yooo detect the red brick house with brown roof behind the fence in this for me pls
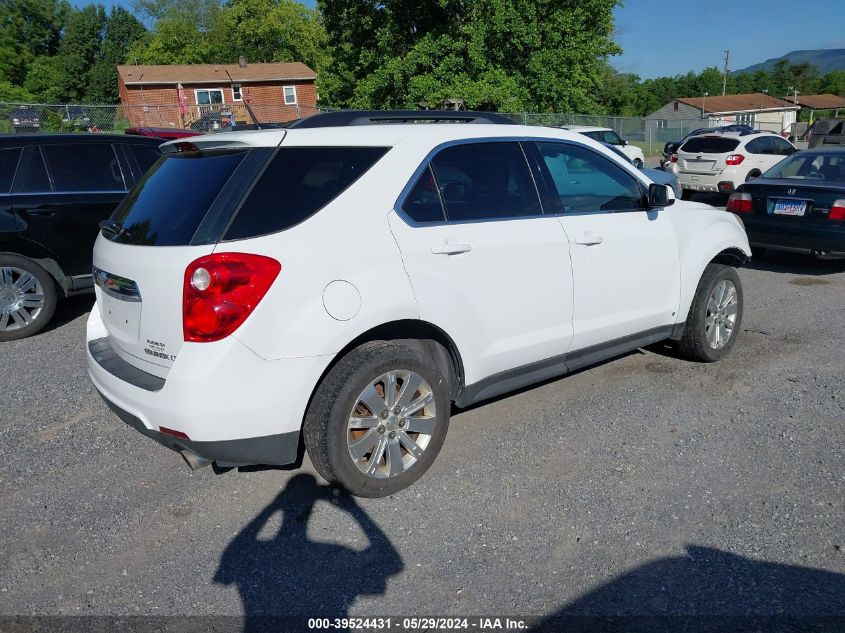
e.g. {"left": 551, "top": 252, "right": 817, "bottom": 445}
{"left": 117, "top": 59, "right": 318, "bottom": 127}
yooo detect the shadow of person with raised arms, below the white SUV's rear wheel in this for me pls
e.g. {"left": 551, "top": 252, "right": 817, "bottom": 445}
{"left": 214, "top": 474, "right": 404, "bottom": 633}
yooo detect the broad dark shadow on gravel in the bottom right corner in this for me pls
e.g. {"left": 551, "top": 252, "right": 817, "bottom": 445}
{"left": 530, "top": 545, "right": 845, "bottom": 633}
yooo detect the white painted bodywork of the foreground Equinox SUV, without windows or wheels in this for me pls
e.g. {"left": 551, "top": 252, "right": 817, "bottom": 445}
{"left": 87, "top": 124, "right": 750, "bottom": 456}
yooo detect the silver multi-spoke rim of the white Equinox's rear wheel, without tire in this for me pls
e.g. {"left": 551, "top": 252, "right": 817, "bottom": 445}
{"left": 346, "top": 369, "right": 437, "bottom": 479}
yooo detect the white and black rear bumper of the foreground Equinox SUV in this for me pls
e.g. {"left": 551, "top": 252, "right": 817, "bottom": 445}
{"left": 86, "top": 307, "right": 331, "bottom": 466}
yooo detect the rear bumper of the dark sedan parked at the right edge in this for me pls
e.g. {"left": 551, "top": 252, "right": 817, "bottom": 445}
{"left": 740, "top": 216, "right": 845, "bottom": 257}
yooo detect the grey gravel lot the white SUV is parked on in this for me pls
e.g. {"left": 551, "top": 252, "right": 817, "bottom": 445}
{"left": 0, "top": 249, "right": 845, "bottom": 630}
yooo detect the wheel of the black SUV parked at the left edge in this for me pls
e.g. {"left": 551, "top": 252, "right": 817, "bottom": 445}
{"left": 0, "top": 253, "right": 59, "bottom": 342}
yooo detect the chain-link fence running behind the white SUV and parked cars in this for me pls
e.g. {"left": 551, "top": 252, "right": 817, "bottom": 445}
{"left": 0, "top": 103, "right": 708, "bottom": 156}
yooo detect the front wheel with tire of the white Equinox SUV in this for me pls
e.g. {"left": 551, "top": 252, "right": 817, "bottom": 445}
{"left": 679, "top": 264, "right": 743, "bottom": 363}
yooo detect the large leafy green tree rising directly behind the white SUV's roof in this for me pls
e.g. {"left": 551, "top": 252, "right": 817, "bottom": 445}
{"left": 318, "top": 0, "right": 620, "bottom": 112}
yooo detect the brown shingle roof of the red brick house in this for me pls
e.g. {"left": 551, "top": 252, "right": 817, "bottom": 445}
{"left": 117, "top": 62, "right": 317, "bottom": 86}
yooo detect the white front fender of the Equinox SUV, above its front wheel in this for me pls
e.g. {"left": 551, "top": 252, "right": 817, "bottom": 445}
{"left": 669, "top": 200, "right": 751, "bottom": 322}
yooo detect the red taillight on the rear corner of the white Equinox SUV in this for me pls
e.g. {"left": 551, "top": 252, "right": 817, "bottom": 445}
{"left": 182, "top": 253, "right": 282, "bottom": 343}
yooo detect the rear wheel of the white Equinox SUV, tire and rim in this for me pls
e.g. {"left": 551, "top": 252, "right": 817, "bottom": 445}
{"left": 303, "top": 342, "right": 451, "bottom": 497}
